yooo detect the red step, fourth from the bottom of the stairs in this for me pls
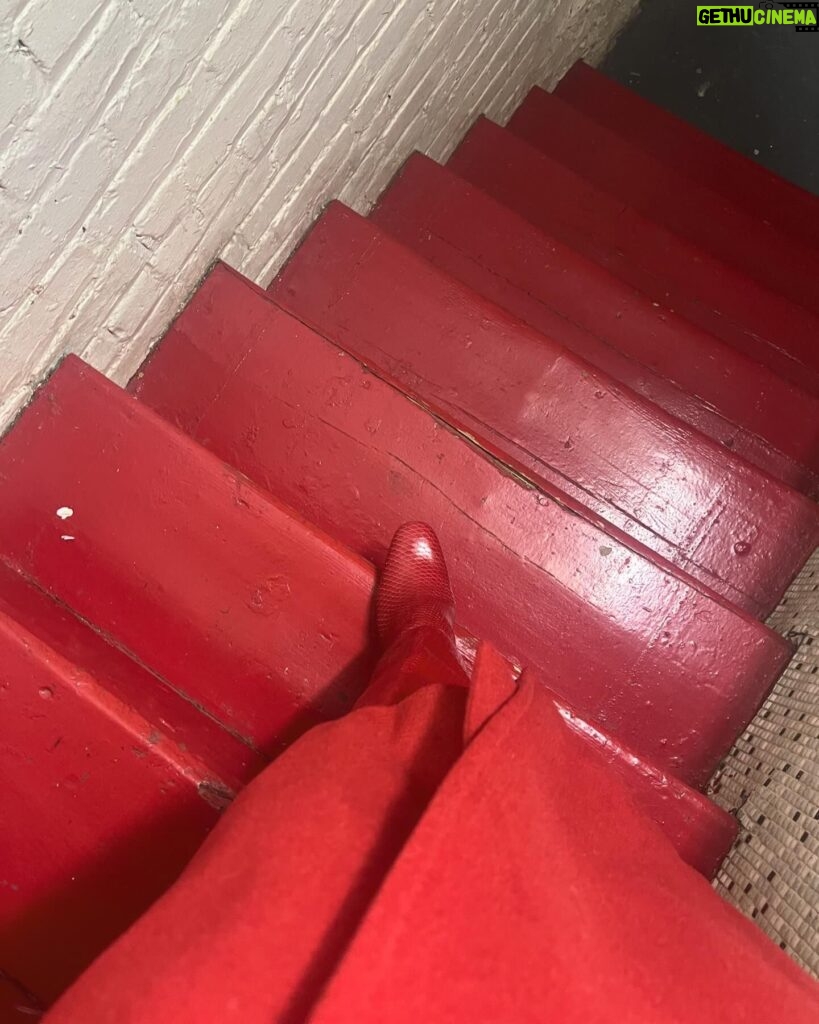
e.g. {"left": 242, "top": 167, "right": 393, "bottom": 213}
{"left": 370, "top": 154, "right": 819, "bottom": 497}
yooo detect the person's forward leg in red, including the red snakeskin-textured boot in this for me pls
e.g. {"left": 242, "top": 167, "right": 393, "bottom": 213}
{"left": 43, "top": 524, "right": 468, "bottom": 1024}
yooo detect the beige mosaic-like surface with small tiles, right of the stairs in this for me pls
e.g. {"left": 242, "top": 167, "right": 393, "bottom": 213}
{"left": 708, "top": 549, "right": 819, "bottom": 977}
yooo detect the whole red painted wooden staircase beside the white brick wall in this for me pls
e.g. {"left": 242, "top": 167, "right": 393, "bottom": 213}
{"left": 0, "top": 66, "right": 819, "bottom": 1020}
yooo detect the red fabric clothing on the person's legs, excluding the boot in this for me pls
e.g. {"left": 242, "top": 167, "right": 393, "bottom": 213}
{"left": 47, "top": 629, "right": 819, "bottom": 1024}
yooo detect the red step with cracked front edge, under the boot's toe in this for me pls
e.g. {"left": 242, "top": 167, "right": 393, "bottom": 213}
{"left": 135, "top": 264, "right": 788, "bottom": 783}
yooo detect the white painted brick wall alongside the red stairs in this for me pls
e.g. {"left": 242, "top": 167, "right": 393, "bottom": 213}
{"left": 0, "top": 0, "right": 636, "bottom": 428}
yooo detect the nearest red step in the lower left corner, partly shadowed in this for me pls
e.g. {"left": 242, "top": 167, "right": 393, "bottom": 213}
{"left": 0, "top": 561, "right": 257, "bottom": 1002}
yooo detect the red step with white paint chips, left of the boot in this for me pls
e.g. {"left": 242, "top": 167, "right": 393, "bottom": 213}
{"left": 0, "top": 358, "right": 375, "bottom": 754}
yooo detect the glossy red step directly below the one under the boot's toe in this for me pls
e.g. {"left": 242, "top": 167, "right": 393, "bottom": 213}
{"left": 270, "top": 204, "right": 819, "bottom": 615}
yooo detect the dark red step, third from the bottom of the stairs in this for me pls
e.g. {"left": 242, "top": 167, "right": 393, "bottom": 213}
{"left": 447, "top": 118, "right": 819, "bottom": 394}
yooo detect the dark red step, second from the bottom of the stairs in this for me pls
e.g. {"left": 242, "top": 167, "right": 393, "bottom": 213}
{"left": 507, "top": 87, "right": 819, "bottom": 333}
